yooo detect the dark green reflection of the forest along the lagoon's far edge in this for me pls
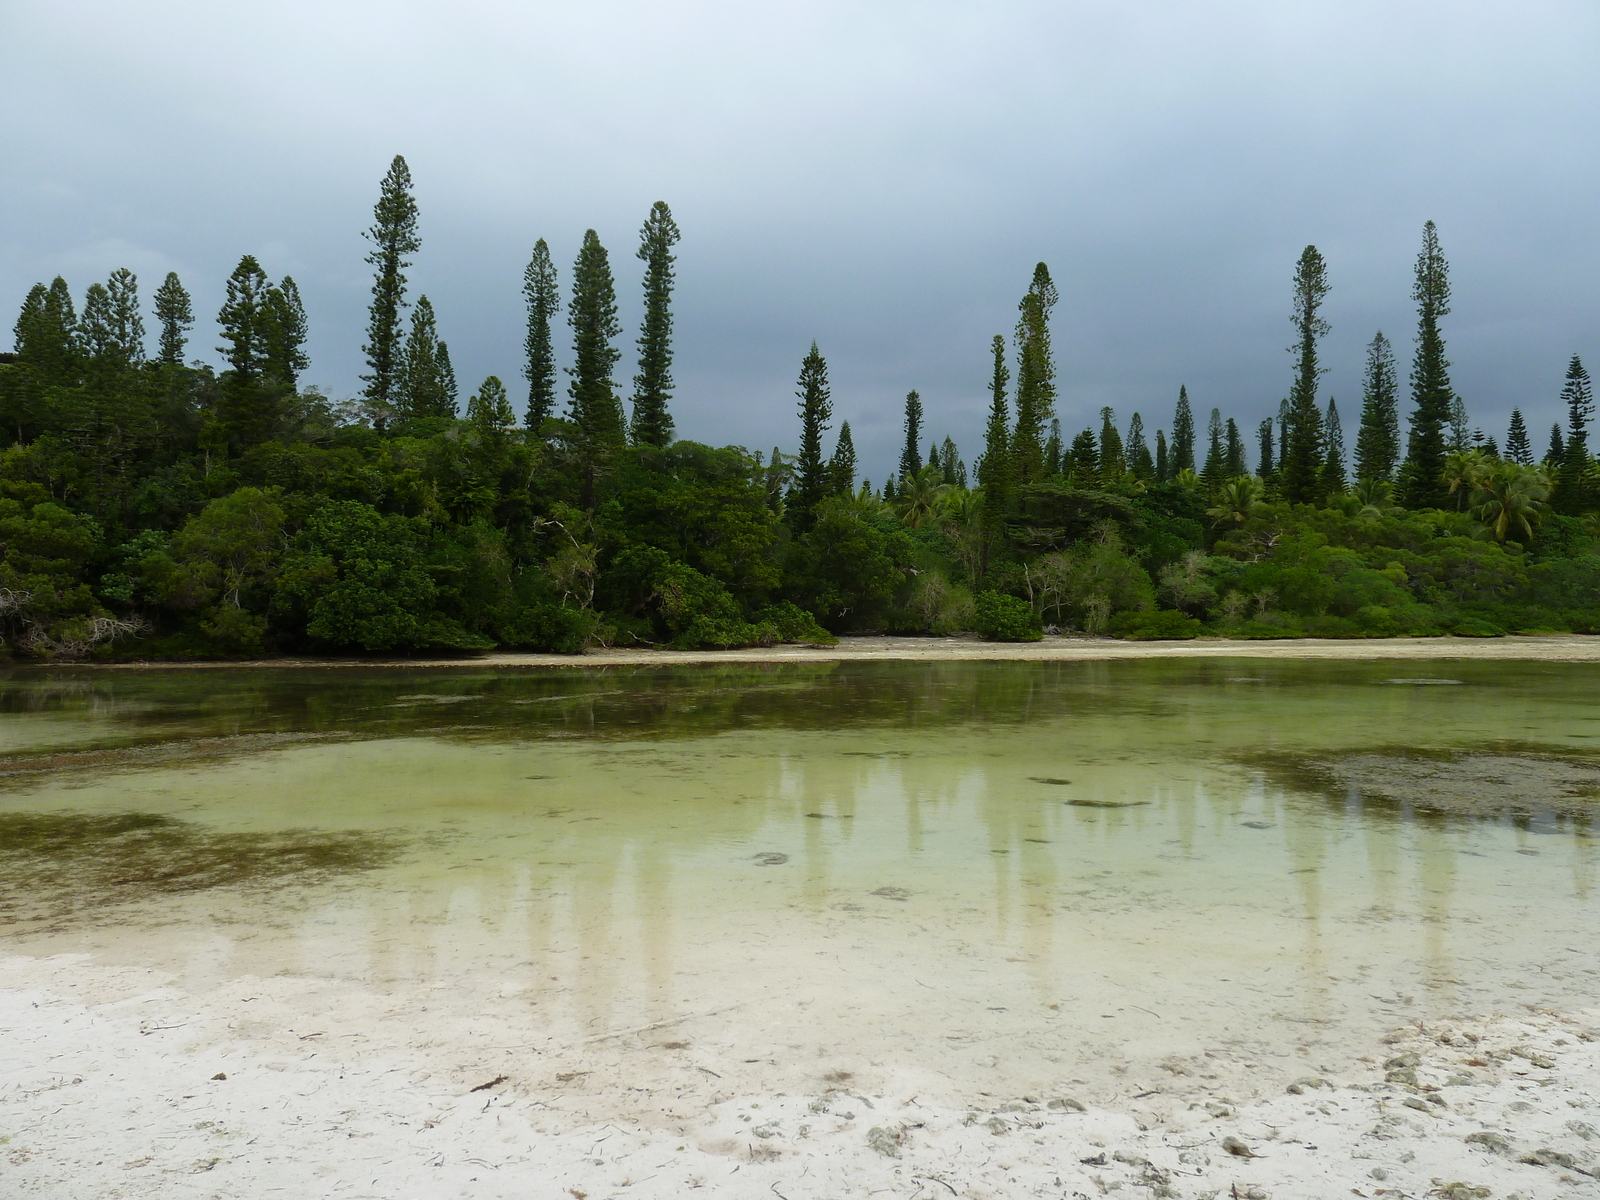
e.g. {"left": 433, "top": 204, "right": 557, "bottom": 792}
{"left": 9, "top": 659, "right": 1600, "bottom": 750}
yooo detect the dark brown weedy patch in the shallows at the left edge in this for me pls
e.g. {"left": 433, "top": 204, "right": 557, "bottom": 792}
{"left": 0, "top": 813, "right": 408, "bottom": 928}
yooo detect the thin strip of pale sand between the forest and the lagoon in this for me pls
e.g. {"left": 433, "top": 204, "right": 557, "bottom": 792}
{"left": 59, "top": 634, "right": 1600, "bottom": 670}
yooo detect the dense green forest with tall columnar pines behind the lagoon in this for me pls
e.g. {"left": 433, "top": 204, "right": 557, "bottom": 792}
{"left": 0, "top": 158, "right": 1600, "bottom": 659}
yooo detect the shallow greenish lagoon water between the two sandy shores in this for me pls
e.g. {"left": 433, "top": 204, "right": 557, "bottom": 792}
{"left": 0, "top": 659, "right": 1600, "bottom": 1104}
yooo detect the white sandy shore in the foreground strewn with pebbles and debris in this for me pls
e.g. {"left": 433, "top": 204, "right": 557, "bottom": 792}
{"left": 0, "top": 955, "right": 1600, "bottom": 1200}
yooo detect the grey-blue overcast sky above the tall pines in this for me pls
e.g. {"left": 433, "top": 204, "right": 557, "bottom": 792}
{"left": 0, "top": 0, "right": 1600, "bottom": 482}
